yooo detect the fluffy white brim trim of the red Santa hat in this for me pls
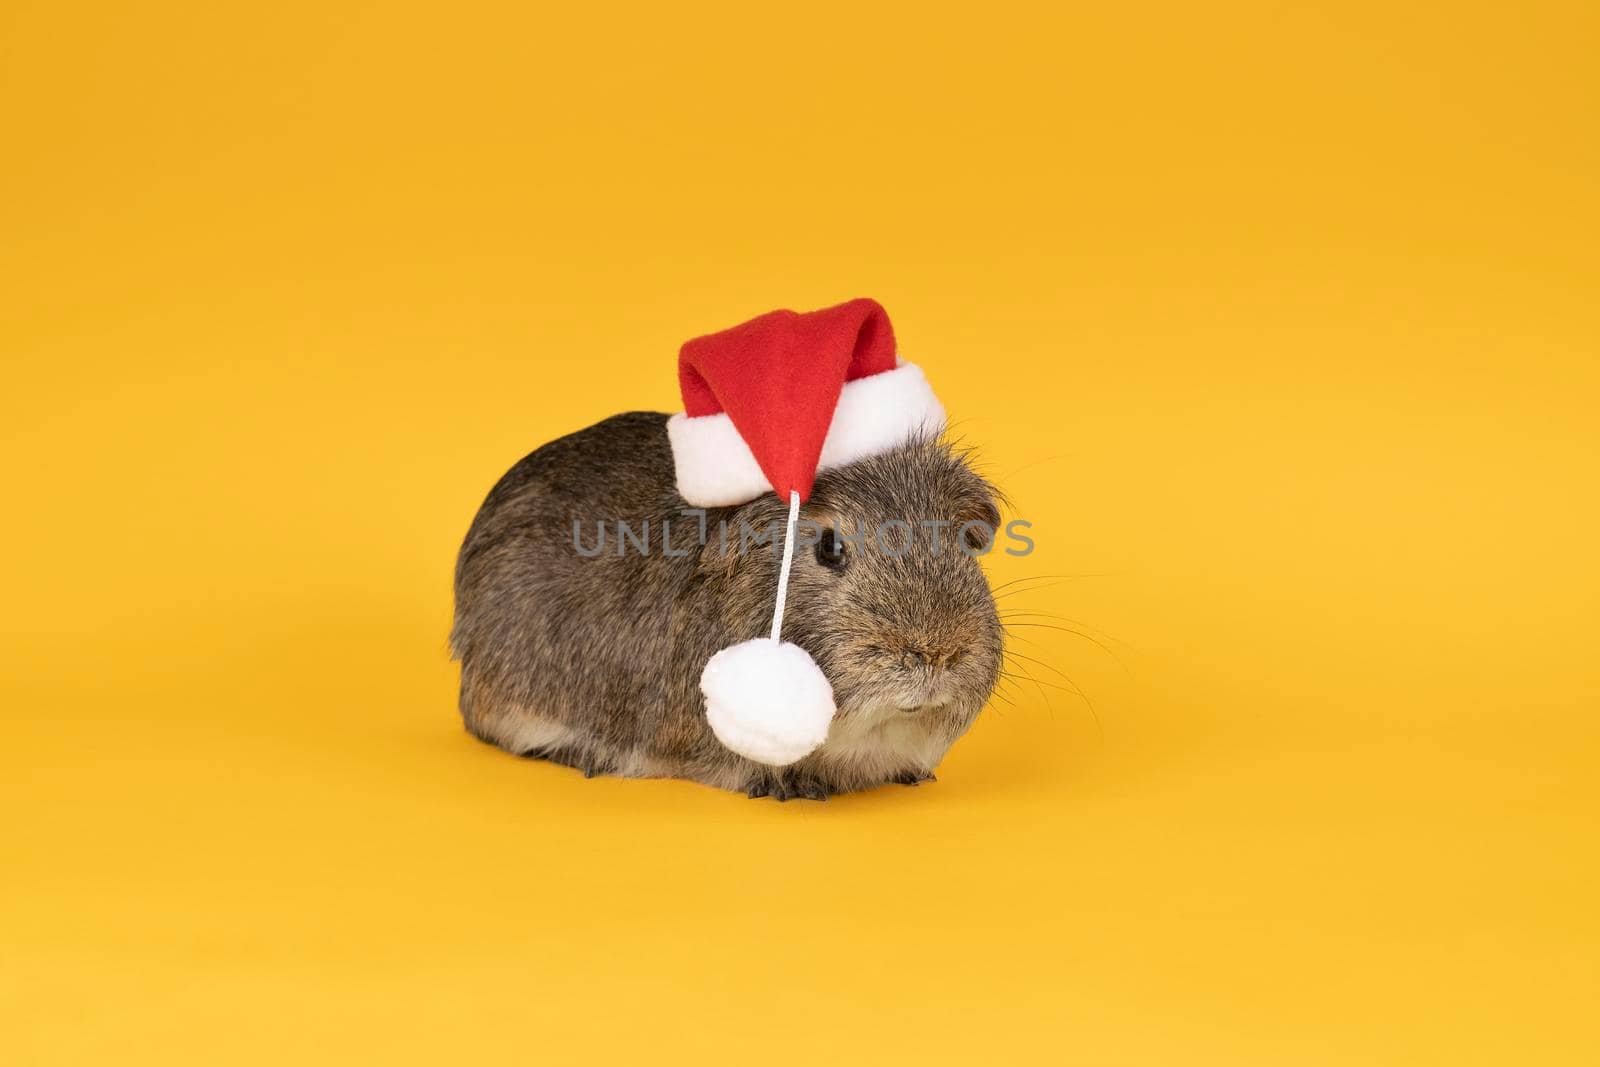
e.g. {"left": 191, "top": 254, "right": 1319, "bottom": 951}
{"left": 667, "top": 363, "right": 944, "bottom": 507}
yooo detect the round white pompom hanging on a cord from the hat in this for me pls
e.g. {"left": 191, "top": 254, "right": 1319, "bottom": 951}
{"left": 701, "top": 637, "right": 834, "bottom": 766}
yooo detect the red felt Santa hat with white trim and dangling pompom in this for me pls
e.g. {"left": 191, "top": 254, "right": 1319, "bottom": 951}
{"left": 667, "top": 299, "right": 944, "bottom": 766}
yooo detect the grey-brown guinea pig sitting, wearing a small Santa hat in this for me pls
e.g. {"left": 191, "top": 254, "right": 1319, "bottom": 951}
{"left": 451, "top": 411, "right": 1003, "bottom": 800}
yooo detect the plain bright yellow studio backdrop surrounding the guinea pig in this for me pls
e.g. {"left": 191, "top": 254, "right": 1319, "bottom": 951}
{"left": 0, "top": 0, "right": 1600, "bottom": 1064}
